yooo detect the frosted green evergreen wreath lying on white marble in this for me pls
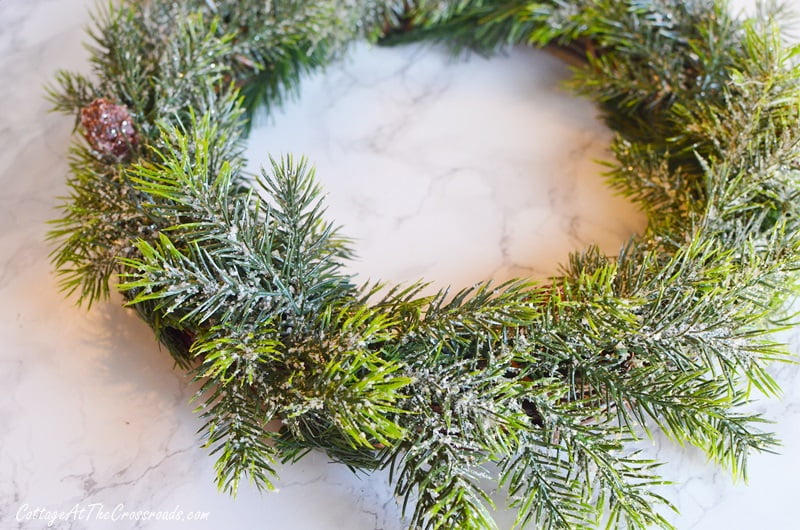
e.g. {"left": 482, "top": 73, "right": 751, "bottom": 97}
{"left": 51, "top": 0, "right": 800, "bottom": 529}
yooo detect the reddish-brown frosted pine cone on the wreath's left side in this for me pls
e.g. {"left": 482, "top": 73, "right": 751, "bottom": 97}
{"left": 81, "top": 98, "right": 139, "bottom": 162}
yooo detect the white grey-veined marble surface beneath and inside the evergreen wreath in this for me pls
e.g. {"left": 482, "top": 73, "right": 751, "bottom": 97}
{"left": 0, "top": 0, "right": 800, "bottom": 530}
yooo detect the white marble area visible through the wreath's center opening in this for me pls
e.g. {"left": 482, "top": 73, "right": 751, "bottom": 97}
{"left": 247, "top": 45, "right": 645, "bottom": 288}
